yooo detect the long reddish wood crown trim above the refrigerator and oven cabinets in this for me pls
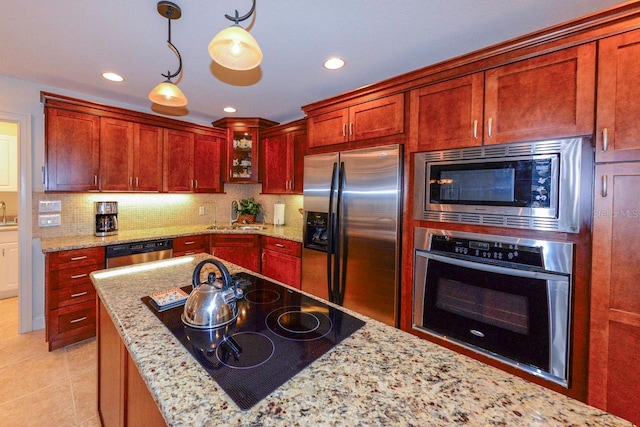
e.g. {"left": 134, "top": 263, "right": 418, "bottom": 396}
{"left": 302, "top": 1, "right": 640, "bottom": 116}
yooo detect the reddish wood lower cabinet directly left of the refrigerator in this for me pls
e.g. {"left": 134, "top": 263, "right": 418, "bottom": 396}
{"left": 261, "top": 236, "right": 302, "bottom": 289}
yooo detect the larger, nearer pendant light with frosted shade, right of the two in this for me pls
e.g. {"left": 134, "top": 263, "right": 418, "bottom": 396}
{"left": 209, "top": 0, "right": 262, "bottom": 71}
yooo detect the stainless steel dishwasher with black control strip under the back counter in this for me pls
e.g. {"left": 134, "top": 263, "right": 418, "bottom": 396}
{"left": 105, "top": 239, "right": 173, "bottom": 268}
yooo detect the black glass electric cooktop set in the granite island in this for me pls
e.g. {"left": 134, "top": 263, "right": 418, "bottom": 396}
{"left": 142, "top": 273, "right": 365, "bottom": 410}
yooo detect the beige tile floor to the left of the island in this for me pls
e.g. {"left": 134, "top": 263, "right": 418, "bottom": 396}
{"left": 0, "top": 297, "right": 100, "bottom": 427}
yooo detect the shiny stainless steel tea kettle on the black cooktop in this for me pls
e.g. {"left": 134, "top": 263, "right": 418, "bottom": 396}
{"left": 182, "top": 259, "right": 242, "bottom": 329}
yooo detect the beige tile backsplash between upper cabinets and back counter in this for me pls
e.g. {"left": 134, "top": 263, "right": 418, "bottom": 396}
{"left": 31, "top": 184, "right": 302, "bottom": 238}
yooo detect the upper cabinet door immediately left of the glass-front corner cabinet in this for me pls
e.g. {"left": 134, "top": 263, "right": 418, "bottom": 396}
{"left": 193, "top": 135, "right": 225, "bottom": 193}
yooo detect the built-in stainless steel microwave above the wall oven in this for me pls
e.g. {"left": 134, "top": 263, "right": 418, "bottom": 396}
{"left": 414, "top": 138, "right": 592, "bottom": 233}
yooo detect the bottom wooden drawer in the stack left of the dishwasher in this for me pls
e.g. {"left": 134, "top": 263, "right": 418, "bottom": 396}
{"left": 49, "top": 298, "right": 96, "bottom": 341}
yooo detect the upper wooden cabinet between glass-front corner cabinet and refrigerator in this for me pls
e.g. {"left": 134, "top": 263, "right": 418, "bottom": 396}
{"left": 260, "top": 120, "right": 307, "bottom": 194}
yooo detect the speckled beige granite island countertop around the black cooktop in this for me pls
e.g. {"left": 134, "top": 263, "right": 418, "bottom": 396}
{"left": 92, "top": 254, "right": 631, "bottom": 426}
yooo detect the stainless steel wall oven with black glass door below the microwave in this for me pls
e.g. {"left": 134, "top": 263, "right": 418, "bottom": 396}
{"left": 413, "top": 228, "right": 573, "bottom": 387}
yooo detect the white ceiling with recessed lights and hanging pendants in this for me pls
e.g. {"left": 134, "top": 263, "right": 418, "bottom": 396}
{"left": 0, "top": 0, "right": 623, "bottom": 123}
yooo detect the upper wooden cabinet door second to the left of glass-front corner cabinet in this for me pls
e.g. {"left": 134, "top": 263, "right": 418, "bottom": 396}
{"left": 162, "top": 129, "right": 194, "bottom": 192}
